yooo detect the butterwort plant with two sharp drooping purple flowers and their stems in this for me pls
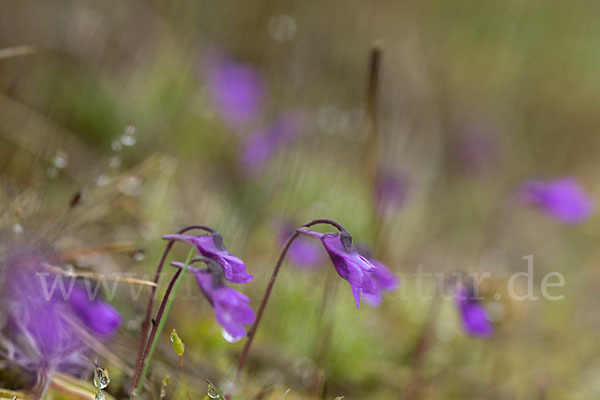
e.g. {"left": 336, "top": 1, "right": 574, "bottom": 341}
{"left": 130, "top": 225, "right": 254, "bottom": 398}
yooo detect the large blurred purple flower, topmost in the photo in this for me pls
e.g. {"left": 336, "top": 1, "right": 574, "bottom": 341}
{"left": 208, "top": 54, "right": 265, "bottom": 128}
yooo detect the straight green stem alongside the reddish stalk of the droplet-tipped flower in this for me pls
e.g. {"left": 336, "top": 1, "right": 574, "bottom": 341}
{"left": 132, "top": 249, "right": 195, "bottom": 397}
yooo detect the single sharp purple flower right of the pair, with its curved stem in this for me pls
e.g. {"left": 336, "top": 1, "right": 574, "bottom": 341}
{"left": 237, "top": 219, "right": 386, "bottom": 377}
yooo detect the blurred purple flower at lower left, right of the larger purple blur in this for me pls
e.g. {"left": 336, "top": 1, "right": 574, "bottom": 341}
{"left": 69, "top": 285, "right": 121, "bottom": 337}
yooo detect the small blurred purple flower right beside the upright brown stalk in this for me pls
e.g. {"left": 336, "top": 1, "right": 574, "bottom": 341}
{"left": 375, "top": 171, "right": 408, "bottom": 215}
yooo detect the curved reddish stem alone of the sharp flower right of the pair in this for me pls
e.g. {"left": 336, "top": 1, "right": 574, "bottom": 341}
{"left": 237, "top": 219, "right": 347, "bottom": 379}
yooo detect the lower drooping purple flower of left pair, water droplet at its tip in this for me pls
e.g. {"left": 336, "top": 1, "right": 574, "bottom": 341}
{"left": 171, "top": 262, "right": 255, "bottom": 342}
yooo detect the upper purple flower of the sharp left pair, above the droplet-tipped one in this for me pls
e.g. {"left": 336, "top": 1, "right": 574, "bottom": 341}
{"left": 163, "top": 232, "right": 253, "bottom": 283}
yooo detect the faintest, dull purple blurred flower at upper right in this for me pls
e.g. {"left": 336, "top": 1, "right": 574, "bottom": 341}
{"left": 451, "top": 122, "right": 499, "bottom": 175}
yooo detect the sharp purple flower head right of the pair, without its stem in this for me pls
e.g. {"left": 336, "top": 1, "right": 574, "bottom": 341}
{"left": 301, "top": 230, "right": 377, "bottom": 308}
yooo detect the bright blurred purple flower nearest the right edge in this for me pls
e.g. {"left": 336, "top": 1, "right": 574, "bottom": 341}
{"left": 521, "top": 178, "right": 594, "bottom": 224}
